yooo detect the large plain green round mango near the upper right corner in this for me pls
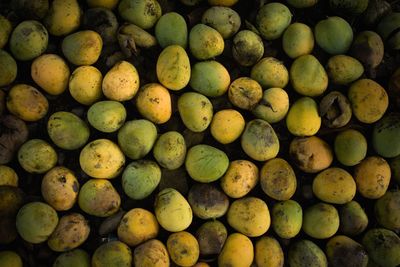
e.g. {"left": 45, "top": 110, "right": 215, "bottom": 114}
{"left": 314, "top": 16, "right": 353, "bottom": 55}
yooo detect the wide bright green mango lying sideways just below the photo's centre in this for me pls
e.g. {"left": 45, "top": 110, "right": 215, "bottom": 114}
{"left": 185, "top": 144, "right": 229, "bottom": 183}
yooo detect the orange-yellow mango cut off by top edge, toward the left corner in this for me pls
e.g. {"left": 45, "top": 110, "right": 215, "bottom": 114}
{"left": 44, "top": 0, "right": 82, "bottom": 36}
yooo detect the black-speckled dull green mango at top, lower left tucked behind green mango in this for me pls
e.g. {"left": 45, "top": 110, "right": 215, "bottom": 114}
{"left": 201, "top": 6, "right": 241, "bottom": 39}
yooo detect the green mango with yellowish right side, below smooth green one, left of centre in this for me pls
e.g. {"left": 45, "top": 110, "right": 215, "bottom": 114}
{"left": 121, "top": 160, "right": 161, "bottom": 200}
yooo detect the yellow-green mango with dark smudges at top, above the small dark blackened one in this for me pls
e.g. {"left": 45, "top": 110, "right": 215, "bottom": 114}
{"left": 256, "top": 2, "right": 292, "bottom": 41}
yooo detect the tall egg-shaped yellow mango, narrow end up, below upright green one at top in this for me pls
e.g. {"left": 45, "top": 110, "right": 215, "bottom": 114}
{"left": 156, "top": 45, "right": 190, "bottom": 91}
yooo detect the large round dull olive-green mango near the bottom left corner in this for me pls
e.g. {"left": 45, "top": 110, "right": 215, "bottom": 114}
{"left": 16, "top": 202, "right": 58, "bottom": 244}
